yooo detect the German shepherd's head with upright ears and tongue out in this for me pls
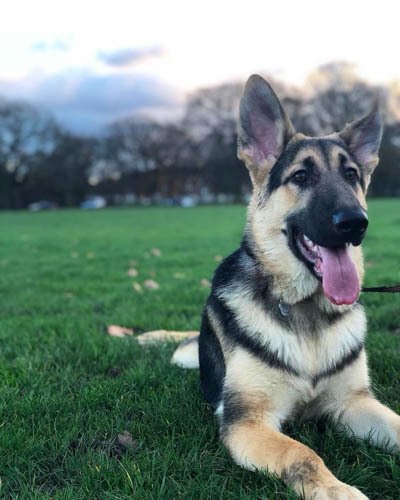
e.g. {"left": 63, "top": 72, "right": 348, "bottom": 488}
{"left": 238, "top": 75, "right": 382, "bottom": 305}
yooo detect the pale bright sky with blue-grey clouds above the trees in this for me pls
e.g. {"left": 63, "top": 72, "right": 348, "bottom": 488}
{"left": 0, "top": 0, "right": 400, "bottom": 134}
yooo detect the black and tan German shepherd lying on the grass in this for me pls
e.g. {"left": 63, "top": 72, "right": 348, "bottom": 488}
{"left": 170, "top": 75, "right": 400, "bottom": 500}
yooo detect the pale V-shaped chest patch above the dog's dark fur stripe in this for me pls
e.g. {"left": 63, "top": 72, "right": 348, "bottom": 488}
{"left": 236, "top": 292, "right": 366, "bottom": 379}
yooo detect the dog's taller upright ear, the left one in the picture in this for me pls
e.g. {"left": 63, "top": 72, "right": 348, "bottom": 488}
{"left": 238, "top": 75, "right": 295, "bottom": 188}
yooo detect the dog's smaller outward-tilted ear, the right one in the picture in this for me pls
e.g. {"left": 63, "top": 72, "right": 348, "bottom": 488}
{"left": 339, "top": 105, "right": 383, "bottom": 175}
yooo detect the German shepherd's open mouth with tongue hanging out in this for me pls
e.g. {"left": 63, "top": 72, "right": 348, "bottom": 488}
{"left": 295, "top": 233, "right": 360, "bottom": 305}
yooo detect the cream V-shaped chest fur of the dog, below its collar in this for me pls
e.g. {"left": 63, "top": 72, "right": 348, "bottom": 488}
{"left": 220, "top": 288, "right": 366, "bottom": 385}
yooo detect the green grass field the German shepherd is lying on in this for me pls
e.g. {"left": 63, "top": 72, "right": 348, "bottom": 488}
{"left": 0, "top": 200, "right": 400, "bottom": 500}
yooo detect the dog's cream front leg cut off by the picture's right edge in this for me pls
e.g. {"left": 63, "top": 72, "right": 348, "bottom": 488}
{"left": 339, "top": 389, "right": 400, "bottom": 453}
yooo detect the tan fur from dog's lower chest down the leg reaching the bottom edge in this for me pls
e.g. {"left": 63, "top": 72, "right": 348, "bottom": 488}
{"left": 223, "top": 349, "right": 366, "bottom": 499}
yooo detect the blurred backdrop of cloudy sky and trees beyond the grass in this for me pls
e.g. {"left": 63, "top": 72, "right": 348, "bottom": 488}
{"left": 0, "top": 0, "right": 400, "bottom": 210}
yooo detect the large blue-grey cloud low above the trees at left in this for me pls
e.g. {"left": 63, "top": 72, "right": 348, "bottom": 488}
{"left": 0, "top": 70, "right": 181, "bottom": 134}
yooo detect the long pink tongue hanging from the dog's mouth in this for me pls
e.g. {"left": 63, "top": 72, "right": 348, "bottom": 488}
{"left": 319, "top": 246, "right": 360, "bottom": 305}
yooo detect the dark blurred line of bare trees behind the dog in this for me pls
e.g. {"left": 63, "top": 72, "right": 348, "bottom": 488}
{"left": 0, "top": 64, "right": 400, "bottom": 209}
